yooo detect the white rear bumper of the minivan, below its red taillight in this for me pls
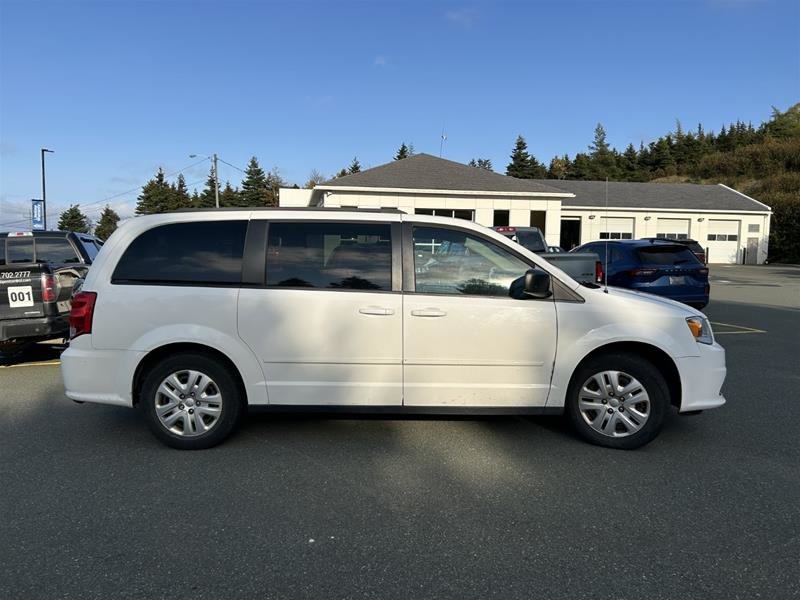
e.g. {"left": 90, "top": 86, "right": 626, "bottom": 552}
{"left": 61, "top": 335, "right": 145, "bottom": 406}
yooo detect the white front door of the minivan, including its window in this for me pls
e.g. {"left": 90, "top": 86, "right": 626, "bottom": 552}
{"left": 403, "top": 225, "right": 556, "bottom": 407}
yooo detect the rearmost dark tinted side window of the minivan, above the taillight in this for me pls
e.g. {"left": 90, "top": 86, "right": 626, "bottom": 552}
{"left": 112, "top": 221, "right": 247, "bottom": 284}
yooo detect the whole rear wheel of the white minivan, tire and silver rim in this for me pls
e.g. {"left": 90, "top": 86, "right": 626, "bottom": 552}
{"left": 139, "top": 354, "right": 244, "bottom": 450}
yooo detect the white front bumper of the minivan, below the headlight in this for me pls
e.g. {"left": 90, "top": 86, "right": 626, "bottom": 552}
{"left": 675, "top": 342, "right": 727, "bottom": 412}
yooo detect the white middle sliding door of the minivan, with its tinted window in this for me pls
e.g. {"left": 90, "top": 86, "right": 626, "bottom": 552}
{"left": 236, "top": 220, "right": 403, "bottom": 406}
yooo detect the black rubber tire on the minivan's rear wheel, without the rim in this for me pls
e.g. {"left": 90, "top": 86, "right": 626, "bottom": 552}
{"left": 139, "top": 353, "right": 245, "bottom": 450}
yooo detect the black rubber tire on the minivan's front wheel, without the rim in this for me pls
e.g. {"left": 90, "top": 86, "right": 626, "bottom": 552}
{"left": 565, "top": 353, "right": 670, "bottom": 450}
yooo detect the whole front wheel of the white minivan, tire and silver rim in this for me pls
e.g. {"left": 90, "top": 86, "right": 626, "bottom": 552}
{"left": 566, "top": 353, "right": 669, "bottom": 450}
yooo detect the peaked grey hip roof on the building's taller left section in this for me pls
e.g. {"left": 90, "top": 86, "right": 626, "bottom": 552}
{"left": 316, "top": 154, "right": 569, "bottom": 197}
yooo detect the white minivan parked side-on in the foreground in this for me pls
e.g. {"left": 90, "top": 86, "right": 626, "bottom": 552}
{"left": 61, "top": 209, "right": 725, "bottom": 449}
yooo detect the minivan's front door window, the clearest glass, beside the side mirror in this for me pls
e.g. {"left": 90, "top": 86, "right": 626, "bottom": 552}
{"left": 414, "top": 227, "right": 531, "bottom": 297}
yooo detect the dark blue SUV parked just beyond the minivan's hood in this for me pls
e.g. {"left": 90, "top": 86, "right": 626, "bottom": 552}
{"left": 577, "top": 238, "right": 711, "bottom": 309}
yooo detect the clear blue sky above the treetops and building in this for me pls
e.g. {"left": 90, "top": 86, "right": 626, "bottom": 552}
{"left": 0, "top": 0, "right": 800, "bottom": 229}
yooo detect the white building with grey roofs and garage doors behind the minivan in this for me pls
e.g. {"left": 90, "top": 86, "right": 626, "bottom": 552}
{"left": 280, "top": 154, "right": 772, "bottom": 264}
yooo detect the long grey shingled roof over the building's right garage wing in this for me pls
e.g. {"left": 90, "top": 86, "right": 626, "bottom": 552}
{"left": 534, "top": 179, "right": 770, "bottom": 212}
